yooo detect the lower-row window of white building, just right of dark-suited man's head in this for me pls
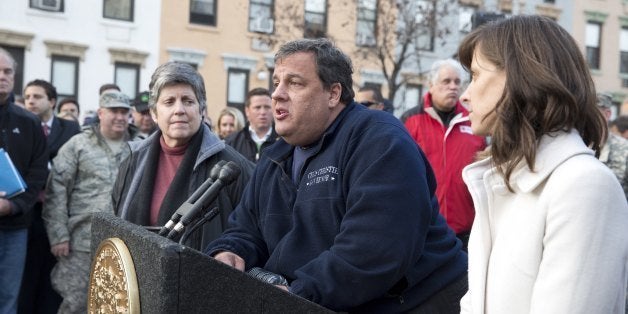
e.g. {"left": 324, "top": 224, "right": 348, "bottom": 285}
{"left": 50, "top": 55, "right": 79, "bottom": 99}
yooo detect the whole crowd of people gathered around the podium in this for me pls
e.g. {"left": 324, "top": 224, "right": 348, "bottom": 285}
{"left": 0, "top": 16, "right": 628, "bottom": 313}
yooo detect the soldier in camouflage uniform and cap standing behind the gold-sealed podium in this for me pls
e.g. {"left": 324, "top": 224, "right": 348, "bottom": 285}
{"left": 42, "top": 92, "right": 139, "bottom": 313}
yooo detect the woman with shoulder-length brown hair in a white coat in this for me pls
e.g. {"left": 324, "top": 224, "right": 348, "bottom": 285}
{"left": 458, "top": 16, "right": 628, "bottom": 313}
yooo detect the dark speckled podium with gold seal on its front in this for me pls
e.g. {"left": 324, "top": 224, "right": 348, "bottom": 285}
{"left": 88, "top": 213, "right": 334, "bottom": 314}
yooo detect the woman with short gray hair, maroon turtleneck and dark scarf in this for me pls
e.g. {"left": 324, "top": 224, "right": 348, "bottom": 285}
{"left": 113, "top": 61, "right": 254, "bottom": 250}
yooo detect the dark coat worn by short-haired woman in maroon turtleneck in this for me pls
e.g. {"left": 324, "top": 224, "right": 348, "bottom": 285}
{"left": 112, "top": 125, "right": 255, "bottom": 250}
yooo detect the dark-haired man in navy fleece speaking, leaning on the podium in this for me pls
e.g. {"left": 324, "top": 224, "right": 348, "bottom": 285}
{"left": 206, "top": 39, "right": 467, "bottom": 313}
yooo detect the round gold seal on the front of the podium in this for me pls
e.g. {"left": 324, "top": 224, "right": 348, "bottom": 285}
{"left": 87, "top": 238, "right": 140, "bottom": 314}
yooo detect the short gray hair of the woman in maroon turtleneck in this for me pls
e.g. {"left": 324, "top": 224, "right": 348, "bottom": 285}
{"left": 148, "top": 61, "right": 207, "bottom": 112}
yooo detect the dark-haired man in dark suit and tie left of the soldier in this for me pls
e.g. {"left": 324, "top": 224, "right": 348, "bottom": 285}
{"left": 18, "top": 80, "right": 81, "bottom": 313}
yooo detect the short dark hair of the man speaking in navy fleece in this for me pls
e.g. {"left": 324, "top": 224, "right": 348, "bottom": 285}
{"left": 275, "top": 38, "right": 355, "bottom": 104}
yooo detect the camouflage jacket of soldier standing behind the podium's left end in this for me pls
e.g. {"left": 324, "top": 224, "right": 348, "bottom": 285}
{"left": 42, "top": 125, "right": 137, "bottom": 252}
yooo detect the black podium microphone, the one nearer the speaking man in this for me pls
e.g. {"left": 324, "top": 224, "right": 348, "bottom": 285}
{"left": 168, "top": 161, "right": 240, "bottom": 239}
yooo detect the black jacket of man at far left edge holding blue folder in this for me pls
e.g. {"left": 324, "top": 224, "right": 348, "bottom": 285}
{"left": 0, "top": 102, "right": 48, "bottom": 229}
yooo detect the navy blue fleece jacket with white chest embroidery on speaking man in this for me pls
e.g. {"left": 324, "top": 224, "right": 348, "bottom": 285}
{"left": 206, "top": 103, "right": 467, "bottom": 312}
